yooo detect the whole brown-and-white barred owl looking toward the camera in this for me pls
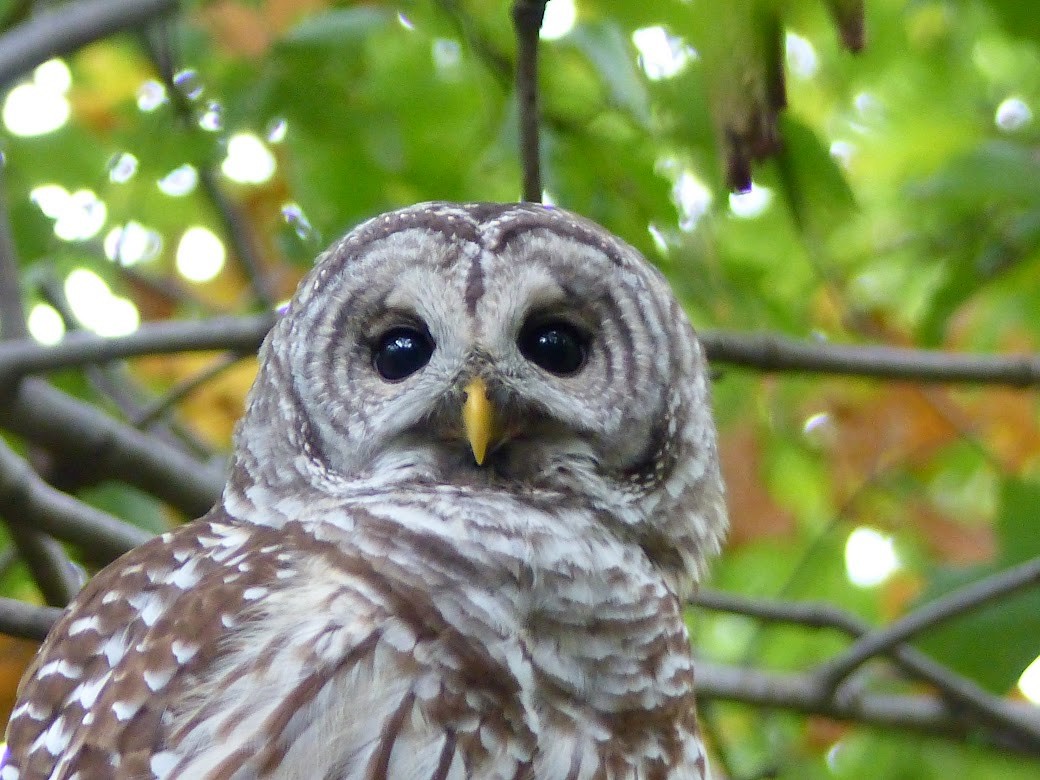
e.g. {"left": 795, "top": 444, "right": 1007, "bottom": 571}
{"left": 0, "top": 203, "right": 726, "bottom": 780}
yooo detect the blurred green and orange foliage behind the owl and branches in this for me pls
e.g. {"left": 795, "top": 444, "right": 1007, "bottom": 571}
{"left": 0, "top": 0, "right": 1040, "bottom": 780}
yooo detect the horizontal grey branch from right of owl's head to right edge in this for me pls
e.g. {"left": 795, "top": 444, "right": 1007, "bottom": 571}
{"left": 700, "top": 331, "right": 1040, "bottom": 387}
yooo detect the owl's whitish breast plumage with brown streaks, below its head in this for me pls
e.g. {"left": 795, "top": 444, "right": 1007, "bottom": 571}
{"left": 162, "top": 489, "right": 703, "bottom": 780}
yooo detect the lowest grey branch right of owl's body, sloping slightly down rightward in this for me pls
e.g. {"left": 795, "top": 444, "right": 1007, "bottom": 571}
{"left": 696, "top": 658, "right": 1040, "bottom": 756}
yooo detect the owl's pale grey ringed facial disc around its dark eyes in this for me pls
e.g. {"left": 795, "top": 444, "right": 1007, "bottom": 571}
{"left": 276, "top": 210, "right": 674, "bottom": 486}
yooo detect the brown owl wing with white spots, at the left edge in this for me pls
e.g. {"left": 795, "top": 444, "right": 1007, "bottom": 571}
{"left": 0, "top": 513, "right": 301, "bottom": 780}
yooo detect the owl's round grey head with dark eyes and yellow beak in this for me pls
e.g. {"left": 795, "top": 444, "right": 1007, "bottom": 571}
{"left": 225, "top": 203, "right": 726, "bottom": 590}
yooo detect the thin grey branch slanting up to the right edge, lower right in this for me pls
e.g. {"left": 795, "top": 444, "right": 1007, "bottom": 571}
{"left": 818, "top": 557, "right": 1040, "bottom": 694}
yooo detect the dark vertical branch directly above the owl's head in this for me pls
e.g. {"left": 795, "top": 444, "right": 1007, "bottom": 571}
{"left": 513, "top": 0, "right": 547, "bottom": 203}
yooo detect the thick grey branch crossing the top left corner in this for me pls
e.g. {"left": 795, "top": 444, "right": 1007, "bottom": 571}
{"left": 0, "top": 0, "right": 177, "bottom": 85}
